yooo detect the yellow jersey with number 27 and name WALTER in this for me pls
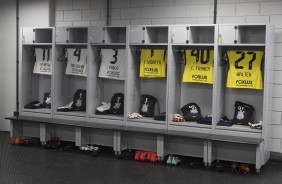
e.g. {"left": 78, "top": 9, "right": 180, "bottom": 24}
{"left": 223, "top": 50, "right": 264, "bottom": 89}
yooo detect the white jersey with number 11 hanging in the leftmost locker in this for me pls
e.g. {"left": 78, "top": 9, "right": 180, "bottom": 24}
{"left": 33, "top": 48, "right": 52, "bottom": 75}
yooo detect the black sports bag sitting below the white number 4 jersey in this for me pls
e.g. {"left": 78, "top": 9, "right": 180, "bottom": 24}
{"left": 72, "top": 89, "right": 86, "bottom": 111}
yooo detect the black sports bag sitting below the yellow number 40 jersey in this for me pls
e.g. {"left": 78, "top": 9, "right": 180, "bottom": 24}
{"left": 180, "top": 102, "right": 203, "bottom": 121}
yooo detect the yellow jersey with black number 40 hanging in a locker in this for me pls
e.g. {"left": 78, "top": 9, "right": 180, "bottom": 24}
{"left": 182, "top": 49, "right": 214, "bottom": 84}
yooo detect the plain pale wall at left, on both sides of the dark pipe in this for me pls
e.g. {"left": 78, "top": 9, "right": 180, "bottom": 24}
{"left": 0, "top": 0, "right": 50, "bottom": 131}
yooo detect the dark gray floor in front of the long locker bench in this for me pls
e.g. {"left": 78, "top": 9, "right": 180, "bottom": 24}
{"left": 0, "top": 132, "right": 282, "bottom": 184}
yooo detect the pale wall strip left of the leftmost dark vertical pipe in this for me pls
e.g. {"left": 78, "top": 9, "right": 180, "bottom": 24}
{"left": 0, "top": 0, "right": 16, "bottom": 130}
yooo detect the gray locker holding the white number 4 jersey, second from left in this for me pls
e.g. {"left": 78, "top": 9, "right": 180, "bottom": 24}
{"left": 53, "top": 27, "right": 89, "bottom": 121}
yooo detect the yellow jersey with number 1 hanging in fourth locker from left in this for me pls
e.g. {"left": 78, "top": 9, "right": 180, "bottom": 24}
{"left": 139, "top": 49, "right": 167, "bottom": 78}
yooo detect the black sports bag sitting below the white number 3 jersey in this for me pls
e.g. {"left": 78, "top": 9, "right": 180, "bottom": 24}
{"left": 110, "top": 93, "right": 124, "bottom": 114}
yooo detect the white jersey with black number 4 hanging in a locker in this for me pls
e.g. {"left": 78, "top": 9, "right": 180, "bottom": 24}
{"left": 66, "top": 48, "right": 87, "bottom": 76}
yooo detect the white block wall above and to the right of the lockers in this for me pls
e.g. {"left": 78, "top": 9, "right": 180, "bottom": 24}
{"left": 55, "top": 0, "right": 282, "bottom": 153}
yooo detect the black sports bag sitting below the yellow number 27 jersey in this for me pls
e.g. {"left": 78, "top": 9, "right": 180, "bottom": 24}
{"left": 232, "top": 101, "right": 255, "bottom": 125}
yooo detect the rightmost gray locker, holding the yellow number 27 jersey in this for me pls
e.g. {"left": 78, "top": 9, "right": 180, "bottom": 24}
{"left": 215, "top": 24, "right": 271, "bottom": 138}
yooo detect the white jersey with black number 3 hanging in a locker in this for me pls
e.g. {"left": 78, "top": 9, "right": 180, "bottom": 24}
{"left": 99, "top": 49, "right": 125, "bottom": 80}
